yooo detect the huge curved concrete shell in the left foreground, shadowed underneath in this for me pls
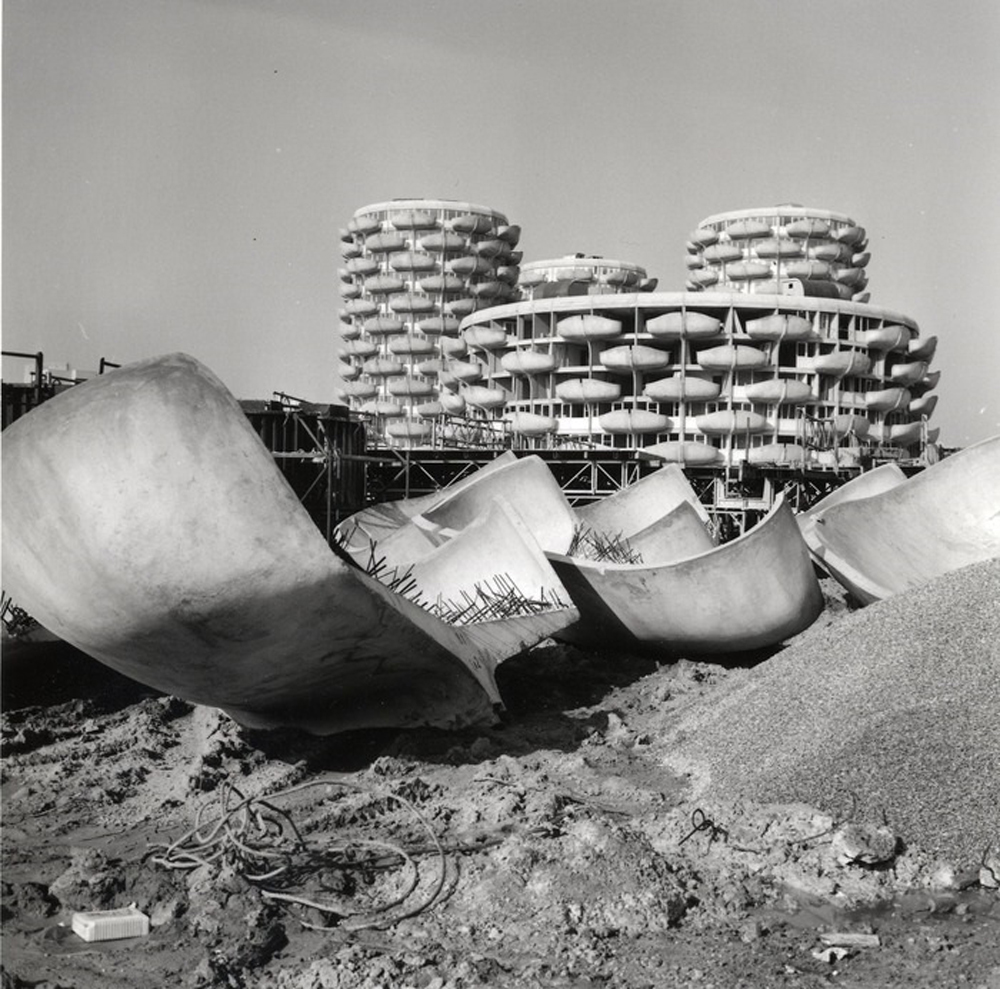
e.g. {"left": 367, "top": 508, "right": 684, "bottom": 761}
{"left": 3, "top": 354, "right": 564, "bottom": 733}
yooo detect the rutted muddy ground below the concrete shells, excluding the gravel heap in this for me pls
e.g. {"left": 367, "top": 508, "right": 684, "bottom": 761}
{"left": 2, "top": 592, "right": 1000, "bottom": 989}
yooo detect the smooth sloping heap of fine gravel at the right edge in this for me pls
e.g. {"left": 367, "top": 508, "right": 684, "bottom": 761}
{"left": 671, "top": 560, "right": 1000, "bottom": 868}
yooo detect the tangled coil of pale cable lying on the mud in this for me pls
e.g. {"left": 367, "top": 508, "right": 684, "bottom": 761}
{"left": 147, "top": 778, "right": 447, "bottom": 930}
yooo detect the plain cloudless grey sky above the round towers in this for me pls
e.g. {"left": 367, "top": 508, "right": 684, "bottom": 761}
{"left": 2, "top": 0, "right": 1000, "bottom": 446}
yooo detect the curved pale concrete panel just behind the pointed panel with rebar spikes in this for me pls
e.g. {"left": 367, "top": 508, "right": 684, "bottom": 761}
{"left": 421, "top": 455, "right": 576, "bottom": 553}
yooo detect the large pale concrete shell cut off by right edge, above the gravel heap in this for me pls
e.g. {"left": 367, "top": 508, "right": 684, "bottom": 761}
{"left": 810, "top": 436, "right": 1000, "bottom": 604}
